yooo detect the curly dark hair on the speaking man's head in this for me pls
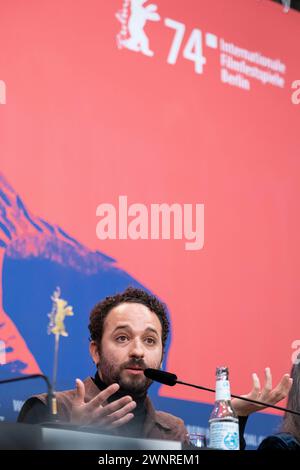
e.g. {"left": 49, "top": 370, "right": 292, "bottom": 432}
{"left": 89, "top": 287, "right": 170, "bottom": 351}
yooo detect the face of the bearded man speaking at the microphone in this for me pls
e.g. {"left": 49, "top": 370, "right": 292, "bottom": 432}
{"left": 91, "top": 302, "right": 163, "bottom": 396}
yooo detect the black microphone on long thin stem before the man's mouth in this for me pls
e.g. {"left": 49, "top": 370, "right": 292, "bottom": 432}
{"left": 144, "top": 368, "right": 300, "bottom": 416}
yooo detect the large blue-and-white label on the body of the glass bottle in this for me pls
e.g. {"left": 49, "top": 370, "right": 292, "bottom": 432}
{"left": 209, "top": 421, "right": 240, "bottom": 450}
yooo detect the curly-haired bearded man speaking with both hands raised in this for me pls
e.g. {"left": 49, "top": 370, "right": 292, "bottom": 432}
{"left": 18, "top": 287, "right": 291, "bottom": 443}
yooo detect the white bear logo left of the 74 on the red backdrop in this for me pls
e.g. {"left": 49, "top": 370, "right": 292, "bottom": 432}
{"left": 116, "top": 0, "right": 160, "bottom": 57}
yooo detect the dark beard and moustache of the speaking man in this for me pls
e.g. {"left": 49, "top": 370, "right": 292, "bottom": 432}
{"left": 98, "top": 353, "right": 152, "bottom": 398}
